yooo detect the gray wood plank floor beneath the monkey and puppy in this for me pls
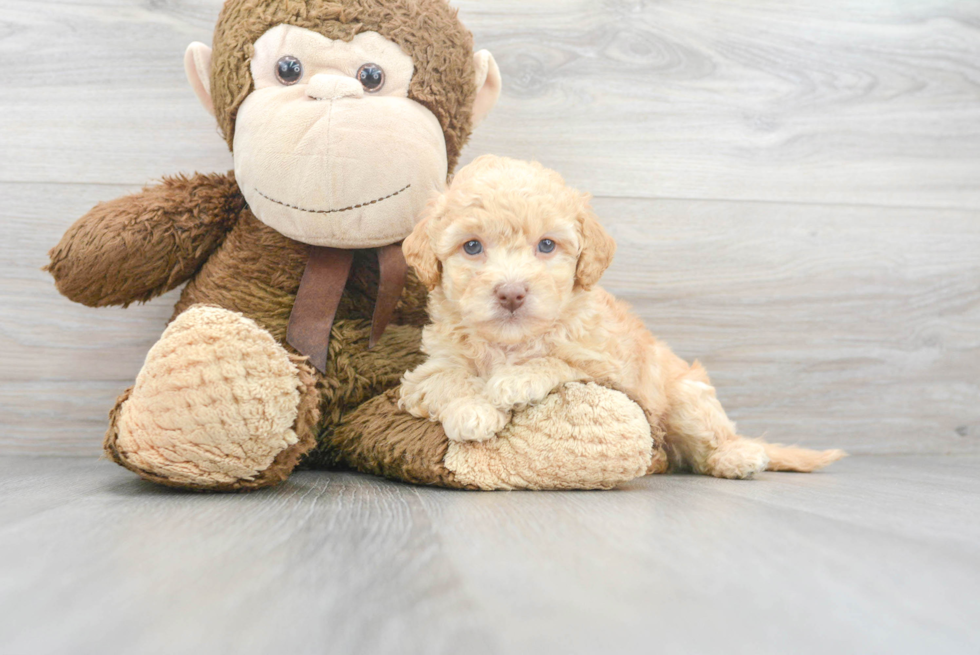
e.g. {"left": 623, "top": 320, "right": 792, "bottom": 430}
{"left": 0, "top": 456, "right": 980, "bottom": 655}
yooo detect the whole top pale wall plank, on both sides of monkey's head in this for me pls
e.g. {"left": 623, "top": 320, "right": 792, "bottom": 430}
{"left": 0, "top": 0, "right": 980, "bottom": 208}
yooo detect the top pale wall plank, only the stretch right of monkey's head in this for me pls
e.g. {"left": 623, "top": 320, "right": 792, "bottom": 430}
{"left": 461, "top": 0, "right": 980, "bottom": 209}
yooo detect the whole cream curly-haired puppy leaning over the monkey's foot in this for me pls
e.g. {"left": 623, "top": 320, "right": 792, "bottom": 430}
{"left": 400, "top": 156, "right": 844, "bottom": 478}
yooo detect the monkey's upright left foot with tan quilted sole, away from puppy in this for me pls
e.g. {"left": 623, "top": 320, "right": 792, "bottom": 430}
{"left": 105, "top": 305, "right": 317, "bottom": 491}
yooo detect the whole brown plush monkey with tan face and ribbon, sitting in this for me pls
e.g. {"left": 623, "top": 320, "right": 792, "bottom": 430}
{"left": 48, "top": 0, "right": 666, "bottom": 490}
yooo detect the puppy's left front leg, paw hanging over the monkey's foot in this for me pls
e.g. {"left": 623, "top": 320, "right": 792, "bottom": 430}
{"left": 398, "top": 359, "right": 510, "bottom": 441}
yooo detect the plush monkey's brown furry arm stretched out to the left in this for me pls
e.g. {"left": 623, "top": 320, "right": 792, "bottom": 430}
{"left": 45, "top": 172, "right": 245, "bottom": 307}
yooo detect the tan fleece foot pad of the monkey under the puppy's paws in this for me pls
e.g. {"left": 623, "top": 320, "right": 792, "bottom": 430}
{"left": 445, "top": 382, "right": 655, "bottom": 490}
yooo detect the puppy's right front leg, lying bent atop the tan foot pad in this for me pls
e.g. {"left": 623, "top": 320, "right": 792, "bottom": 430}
{"left": 485, "top": 357, "right": 585, "bottom": 411}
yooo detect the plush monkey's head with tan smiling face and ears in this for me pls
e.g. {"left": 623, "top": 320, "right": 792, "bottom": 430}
{"left": 184, "top": 0, "right": 500, "bottom": 248}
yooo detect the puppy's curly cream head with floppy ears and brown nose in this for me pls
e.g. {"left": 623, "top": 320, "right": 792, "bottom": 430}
{"left": 403, "top": 155, "right": 616, "bottom": 343}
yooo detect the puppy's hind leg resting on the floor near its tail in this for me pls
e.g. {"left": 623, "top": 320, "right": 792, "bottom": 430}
{"left": 667, "top": 362, "right": 769, "bottom": 478}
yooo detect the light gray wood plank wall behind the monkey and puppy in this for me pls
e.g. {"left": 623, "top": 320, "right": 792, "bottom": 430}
{"left": 0, "top": 0, "right": 980, "bottom": 456}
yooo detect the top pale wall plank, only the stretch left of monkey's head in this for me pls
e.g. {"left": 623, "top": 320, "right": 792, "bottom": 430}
{"left": 0, "top": 0, "right": 231, "bottom": 185}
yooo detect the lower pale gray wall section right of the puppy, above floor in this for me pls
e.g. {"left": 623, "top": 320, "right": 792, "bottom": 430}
{"left": 596, "top": 200, "right": 980, "bottom": 453}
